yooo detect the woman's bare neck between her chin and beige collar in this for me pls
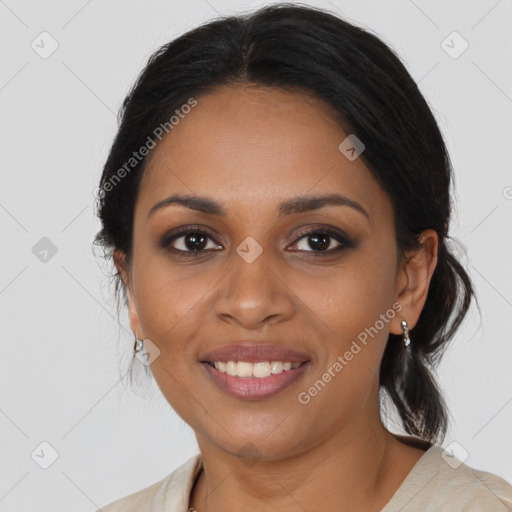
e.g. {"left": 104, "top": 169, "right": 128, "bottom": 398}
{"left": 190, "top": 400, "right": 424, "bottom": 512}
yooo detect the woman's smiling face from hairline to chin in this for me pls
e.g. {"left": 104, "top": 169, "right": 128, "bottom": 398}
{"left": 116, "top": 86, "right": 418, "bottom": 460}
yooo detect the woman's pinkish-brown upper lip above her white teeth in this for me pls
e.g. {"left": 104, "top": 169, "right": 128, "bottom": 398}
{"left": 200, "top": 341, "right": 309, "bottom": 363}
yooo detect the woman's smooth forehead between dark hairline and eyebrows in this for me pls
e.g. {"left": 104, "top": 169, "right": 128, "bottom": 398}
{"left": 138, "top": 85, "right": 389, "bottom": 222}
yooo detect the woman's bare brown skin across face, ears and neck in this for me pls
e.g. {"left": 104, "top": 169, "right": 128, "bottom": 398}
{"left": 114, "top": 84, "right": 438, "bottom": 512}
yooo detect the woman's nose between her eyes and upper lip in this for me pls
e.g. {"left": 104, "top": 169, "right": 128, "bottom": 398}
{"left": 213, "top": 243, "right": 296, "bottom": 329}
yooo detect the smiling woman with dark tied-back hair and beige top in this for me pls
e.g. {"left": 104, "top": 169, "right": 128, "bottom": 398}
{"left": 96, "top": 4, "right": 512, "bottom": 512}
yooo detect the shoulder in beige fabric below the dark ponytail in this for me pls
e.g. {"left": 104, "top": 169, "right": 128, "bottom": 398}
{"left": 382, "top": 446, "right": 512, "bottom": 512}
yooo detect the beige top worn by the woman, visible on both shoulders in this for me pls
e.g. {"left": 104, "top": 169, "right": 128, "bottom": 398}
{"left": 96, "top": 446, "right": 512, "bottom": 512}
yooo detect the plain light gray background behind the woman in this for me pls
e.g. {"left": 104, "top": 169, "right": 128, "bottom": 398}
{"left": 0, "top": 0, "right": 512, "bottom": 512}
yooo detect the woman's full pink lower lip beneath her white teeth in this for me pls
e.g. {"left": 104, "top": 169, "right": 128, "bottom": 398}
{"left": 201, "top": 361, "right": 310, "bottom": 400}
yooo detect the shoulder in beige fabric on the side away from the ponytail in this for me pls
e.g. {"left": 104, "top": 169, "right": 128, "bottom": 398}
{"left": 96, "top": 454, "right": 202, "bottom": 512}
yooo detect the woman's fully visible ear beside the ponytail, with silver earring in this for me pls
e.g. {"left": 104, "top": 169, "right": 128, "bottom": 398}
{"left": 390, "top": 229, "right": 439, "bottom": 334}
